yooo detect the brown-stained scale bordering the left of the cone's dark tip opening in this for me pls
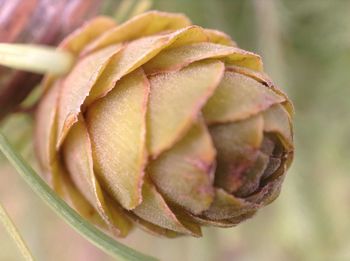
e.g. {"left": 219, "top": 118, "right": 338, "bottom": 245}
{"left": 209, "top": 116, "right": 264, "bottom": 193}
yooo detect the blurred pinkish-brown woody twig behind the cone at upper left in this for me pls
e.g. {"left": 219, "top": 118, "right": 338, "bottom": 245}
{"left": 0, "top": 0, "right": 103, "bottom": 120}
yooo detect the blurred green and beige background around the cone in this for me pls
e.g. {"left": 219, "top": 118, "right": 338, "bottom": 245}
{"left": 0, "top": 0, "right": 350, "bottom": 261}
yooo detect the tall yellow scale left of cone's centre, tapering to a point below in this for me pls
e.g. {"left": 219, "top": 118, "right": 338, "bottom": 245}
{"left": 86, "top": 70, "right": 149, "bottom": 209}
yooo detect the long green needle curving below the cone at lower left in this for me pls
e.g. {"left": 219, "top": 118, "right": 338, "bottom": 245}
{"left": 0, "top": 132, "right": 156, "bottom": 261}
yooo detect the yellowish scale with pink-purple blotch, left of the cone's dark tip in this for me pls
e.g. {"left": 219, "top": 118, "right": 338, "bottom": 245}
{"left": 147, "top": 121, "right": 216, "bottom": 214}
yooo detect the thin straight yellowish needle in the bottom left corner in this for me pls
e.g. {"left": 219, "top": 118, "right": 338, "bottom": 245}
{"left": 0, "top": 203, "right": 34, "bottom": 261}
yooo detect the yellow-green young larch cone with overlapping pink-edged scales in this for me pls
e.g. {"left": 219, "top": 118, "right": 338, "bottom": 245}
{"left": 36, "top": 11, "right": 293, "bottom": 237}
